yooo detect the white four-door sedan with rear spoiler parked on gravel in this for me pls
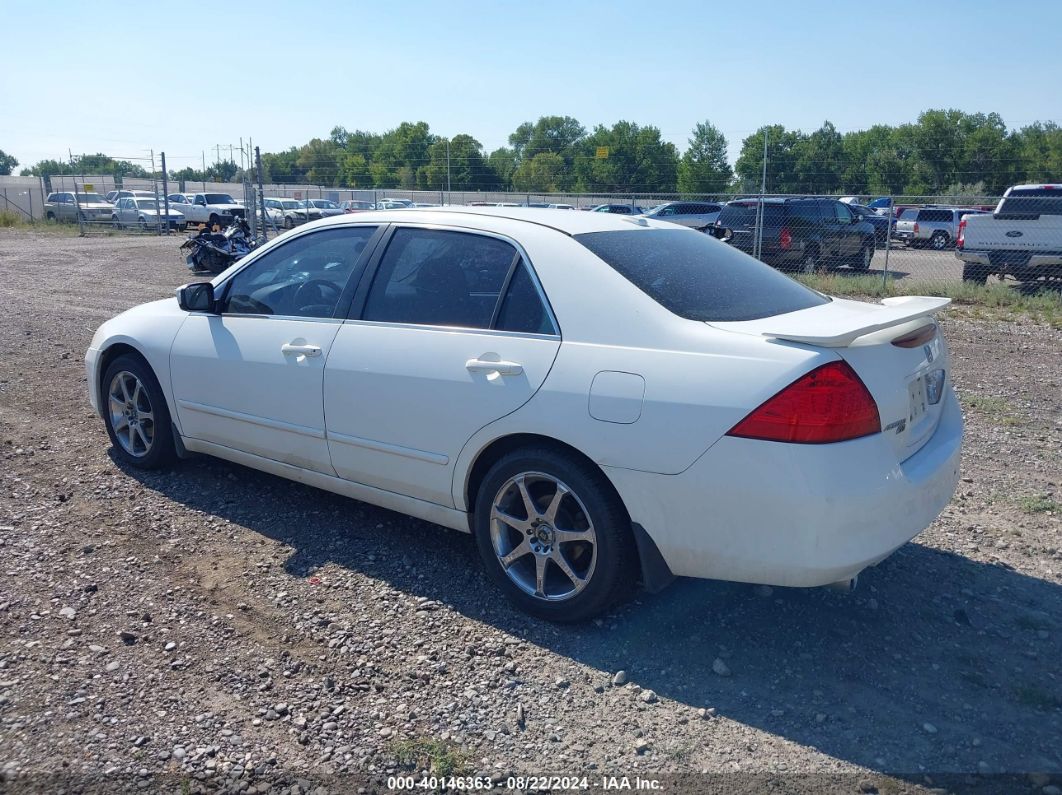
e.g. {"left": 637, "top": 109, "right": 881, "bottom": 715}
{"left": 85, "top": 207, "right": 962, "bottom": 621}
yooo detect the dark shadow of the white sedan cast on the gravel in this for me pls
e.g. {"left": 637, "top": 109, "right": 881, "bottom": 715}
{"left": 122, "top": 450, "right": 1062, "bottom": 776}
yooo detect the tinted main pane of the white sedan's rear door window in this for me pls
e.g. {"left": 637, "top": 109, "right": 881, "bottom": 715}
{"left": 362, "top": 228, "right": 518, "bottom": 328}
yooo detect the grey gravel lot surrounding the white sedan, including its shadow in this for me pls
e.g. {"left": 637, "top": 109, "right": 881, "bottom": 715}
{"left": 0, "top": 230, "right": 1062, "bottom": 795}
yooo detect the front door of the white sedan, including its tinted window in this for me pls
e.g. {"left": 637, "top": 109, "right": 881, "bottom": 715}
{"left": 170, "top": 225, "right": 386, "bottom": 474}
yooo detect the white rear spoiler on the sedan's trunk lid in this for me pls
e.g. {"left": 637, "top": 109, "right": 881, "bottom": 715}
{"left": 710, "top": 295, "right": 952, "bottom": 348}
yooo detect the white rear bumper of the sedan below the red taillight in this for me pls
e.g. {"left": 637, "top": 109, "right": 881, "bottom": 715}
{"left": 605, "top": 390, "right": 962, "bottom": 587}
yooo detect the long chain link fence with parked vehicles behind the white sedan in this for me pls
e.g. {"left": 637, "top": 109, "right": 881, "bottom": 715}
{"left": 16, "top": 154, "right": 1062, "bottom": 290}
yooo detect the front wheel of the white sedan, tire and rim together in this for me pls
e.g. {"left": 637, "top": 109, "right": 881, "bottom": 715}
{"left": 102, "top": 355, "right": 175, "bottom": 469}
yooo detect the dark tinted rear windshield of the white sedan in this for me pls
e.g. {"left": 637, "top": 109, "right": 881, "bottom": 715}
{"left": 575, "top": 229, "right": 829, "bottom": 322}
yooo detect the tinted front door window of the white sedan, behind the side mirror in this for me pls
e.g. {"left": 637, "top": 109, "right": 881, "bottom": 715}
{"left": 222, "top": 226, "right": 376, "bottom": 317}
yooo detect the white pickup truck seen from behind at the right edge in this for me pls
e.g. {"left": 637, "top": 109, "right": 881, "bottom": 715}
{"left": 955, "top": 185, "right": 1062, "bottom": 284}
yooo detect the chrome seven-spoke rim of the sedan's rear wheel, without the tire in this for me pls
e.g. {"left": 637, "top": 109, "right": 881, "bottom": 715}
{"left": 491, "top": 472, "right": 597, "bottom": 602}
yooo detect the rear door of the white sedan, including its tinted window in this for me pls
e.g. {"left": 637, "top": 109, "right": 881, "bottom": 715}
{"left": 325, "top": 225, "right": 560, "bottom": 505}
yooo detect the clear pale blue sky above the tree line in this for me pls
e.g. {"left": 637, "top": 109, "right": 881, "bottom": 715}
{"left": 0, "top": 0, "right": 1062, "bottom": 169}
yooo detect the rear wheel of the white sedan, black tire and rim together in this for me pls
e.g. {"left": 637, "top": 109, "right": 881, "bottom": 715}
{"left": 474, "top": 448, "right": 637, "bottom": 622}
